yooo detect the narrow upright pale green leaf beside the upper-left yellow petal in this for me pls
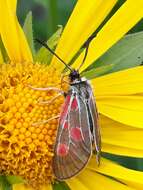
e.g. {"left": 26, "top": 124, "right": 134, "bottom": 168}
{"left": 23, "top": 11, "right": 35, "bottom": 55}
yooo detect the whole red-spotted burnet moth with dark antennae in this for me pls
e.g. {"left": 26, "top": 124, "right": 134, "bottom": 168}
{"left": 37, "top": 35, "right": 101, "bottom": 181}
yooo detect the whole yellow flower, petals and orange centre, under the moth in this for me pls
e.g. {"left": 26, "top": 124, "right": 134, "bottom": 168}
{"left": 0, "top": 0, "right": 143, "bottom": 190}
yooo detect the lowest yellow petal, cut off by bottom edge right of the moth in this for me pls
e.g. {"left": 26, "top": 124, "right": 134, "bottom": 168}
{"left": 77, "top": 169, "right": 135, "bottom": 190}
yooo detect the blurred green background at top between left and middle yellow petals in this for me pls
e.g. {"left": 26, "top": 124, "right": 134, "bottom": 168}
{"left": 17, "top": 0, "right": 76, "bottom": 40}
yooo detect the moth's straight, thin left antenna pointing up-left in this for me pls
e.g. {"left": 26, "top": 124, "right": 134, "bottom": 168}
{"left": 35, "top": 39, "right": 73, "bottom": 71}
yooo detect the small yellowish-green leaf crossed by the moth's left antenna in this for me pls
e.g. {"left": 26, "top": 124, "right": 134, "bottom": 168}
{"left": 35, "top": 26, "right": 63, "bottom": 64}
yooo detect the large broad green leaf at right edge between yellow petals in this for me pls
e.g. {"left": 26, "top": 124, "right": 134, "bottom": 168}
{"left": 91, "top": 32, "right": 143, "bottom": 73}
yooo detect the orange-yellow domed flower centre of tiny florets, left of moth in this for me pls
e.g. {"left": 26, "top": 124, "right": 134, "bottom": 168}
{"left": 0, "top": 63, "right": 68, "bottom": 189}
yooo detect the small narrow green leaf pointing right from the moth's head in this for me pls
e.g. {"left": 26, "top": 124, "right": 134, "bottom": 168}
{"left": 81, "top": 64, "right": 114, "bottom": 79}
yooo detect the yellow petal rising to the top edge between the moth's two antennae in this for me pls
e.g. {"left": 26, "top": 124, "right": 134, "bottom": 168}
{"left": 52, "top": 0, "right": 117, "bottom": 70}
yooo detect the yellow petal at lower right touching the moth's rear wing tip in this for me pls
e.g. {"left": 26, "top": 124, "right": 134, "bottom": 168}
{"left": 88, "top": 158, "right": 143, "bottom": 190}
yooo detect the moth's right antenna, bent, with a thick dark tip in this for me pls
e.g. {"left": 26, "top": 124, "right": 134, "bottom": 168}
{"left": 78, "top": 33, "right": 97, "bottom": 71}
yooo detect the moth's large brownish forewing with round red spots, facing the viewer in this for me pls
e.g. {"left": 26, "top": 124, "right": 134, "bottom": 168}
{"left": 53, "top": 95, "right": 92, "bottom": 180}
